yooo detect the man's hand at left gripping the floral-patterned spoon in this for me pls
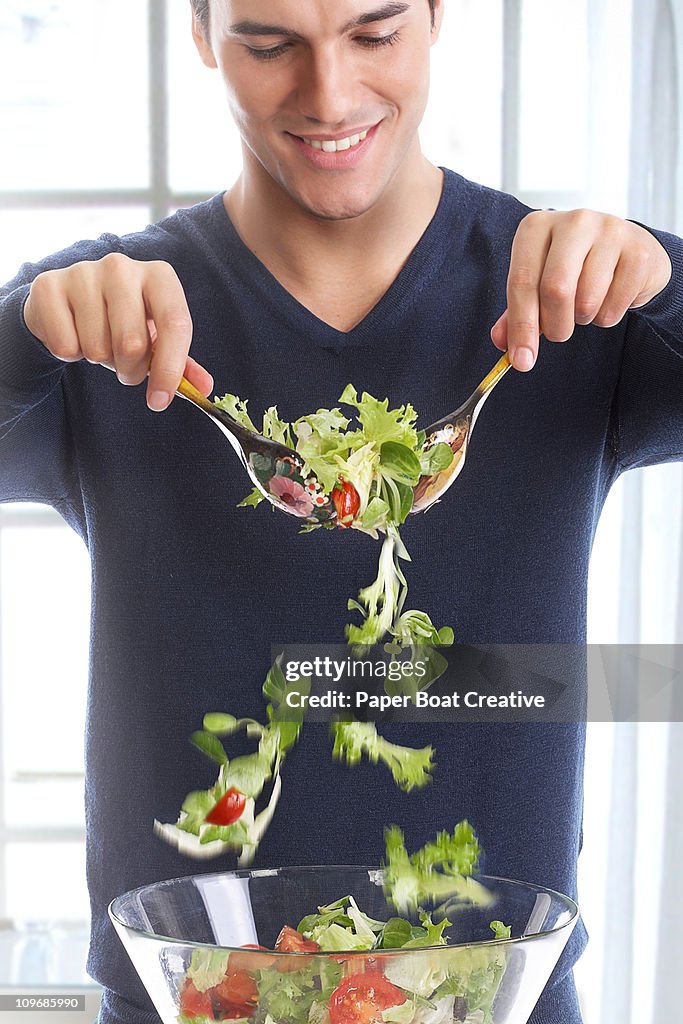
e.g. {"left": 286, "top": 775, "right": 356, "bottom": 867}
{"left": 24, "top": 253, "right": 213, "bottom": 412}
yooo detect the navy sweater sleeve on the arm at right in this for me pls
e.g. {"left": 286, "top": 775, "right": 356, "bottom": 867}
{"left": 613, "top": 225, "right": 683, "bottom": 471}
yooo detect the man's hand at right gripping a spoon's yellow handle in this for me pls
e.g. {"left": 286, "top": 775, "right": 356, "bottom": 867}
{"left": 490, "top": 210, "right": 672, "bottom": 371}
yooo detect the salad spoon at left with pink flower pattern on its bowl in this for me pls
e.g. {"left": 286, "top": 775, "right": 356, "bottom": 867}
{"left": 177, "top": 377, "right": 337, "bottom": 523}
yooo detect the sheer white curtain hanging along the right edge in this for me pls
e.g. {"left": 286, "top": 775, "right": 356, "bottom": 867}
{"left": 578, "top": 0, "right": 683, "bottom": 1024}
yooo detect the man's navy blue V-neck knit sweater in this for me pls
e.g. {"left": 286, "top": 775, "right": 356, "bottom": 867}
{"left": 0, "top": 172, "right": 683, "bottom": 1024}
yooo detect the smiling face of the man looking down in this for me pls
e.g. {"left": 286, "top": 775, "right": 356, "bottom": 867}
{"left": 195, "top": 0, "right": 441, "bottom": 220}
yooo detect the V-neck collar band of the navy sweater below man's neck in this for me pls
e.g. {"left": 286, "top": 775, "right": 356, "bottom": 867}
{"left": 212, "top": 168, "right": 463, "bottom": 348}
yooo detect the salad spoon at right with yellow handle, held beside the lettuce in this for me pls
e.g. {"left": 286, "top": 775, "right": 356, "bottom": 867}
{"left": 411, "top": 352, "right": 512, "bottom": 514}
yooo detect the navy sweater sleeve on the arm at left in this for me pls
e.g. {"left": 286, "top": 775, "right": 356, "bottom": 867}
{"left": 0, "top": 236, "right": 119, "bottom": 518}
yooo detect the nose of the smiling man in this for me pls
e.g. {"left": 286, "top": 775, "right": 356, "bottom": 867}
{"left": 297, "top": 47, "right": 357, "bottom": 128}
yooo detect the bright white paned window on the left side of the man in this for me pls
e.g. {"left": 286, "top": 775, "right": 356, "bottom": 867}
{"left": 0, "top": 0, "right": 216, "bottom": 987}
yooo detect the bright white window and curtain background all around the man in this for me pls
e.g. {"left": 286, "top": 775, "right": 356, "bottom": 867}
{"left": 0, "top": 0, "right": 683, "bottom": 1024}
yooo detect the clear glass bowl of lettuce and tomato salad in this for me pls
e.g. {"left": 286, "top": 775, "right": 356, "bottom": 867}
{"left": 110, "top": 866, "right": 579, "bottom": 1024}
